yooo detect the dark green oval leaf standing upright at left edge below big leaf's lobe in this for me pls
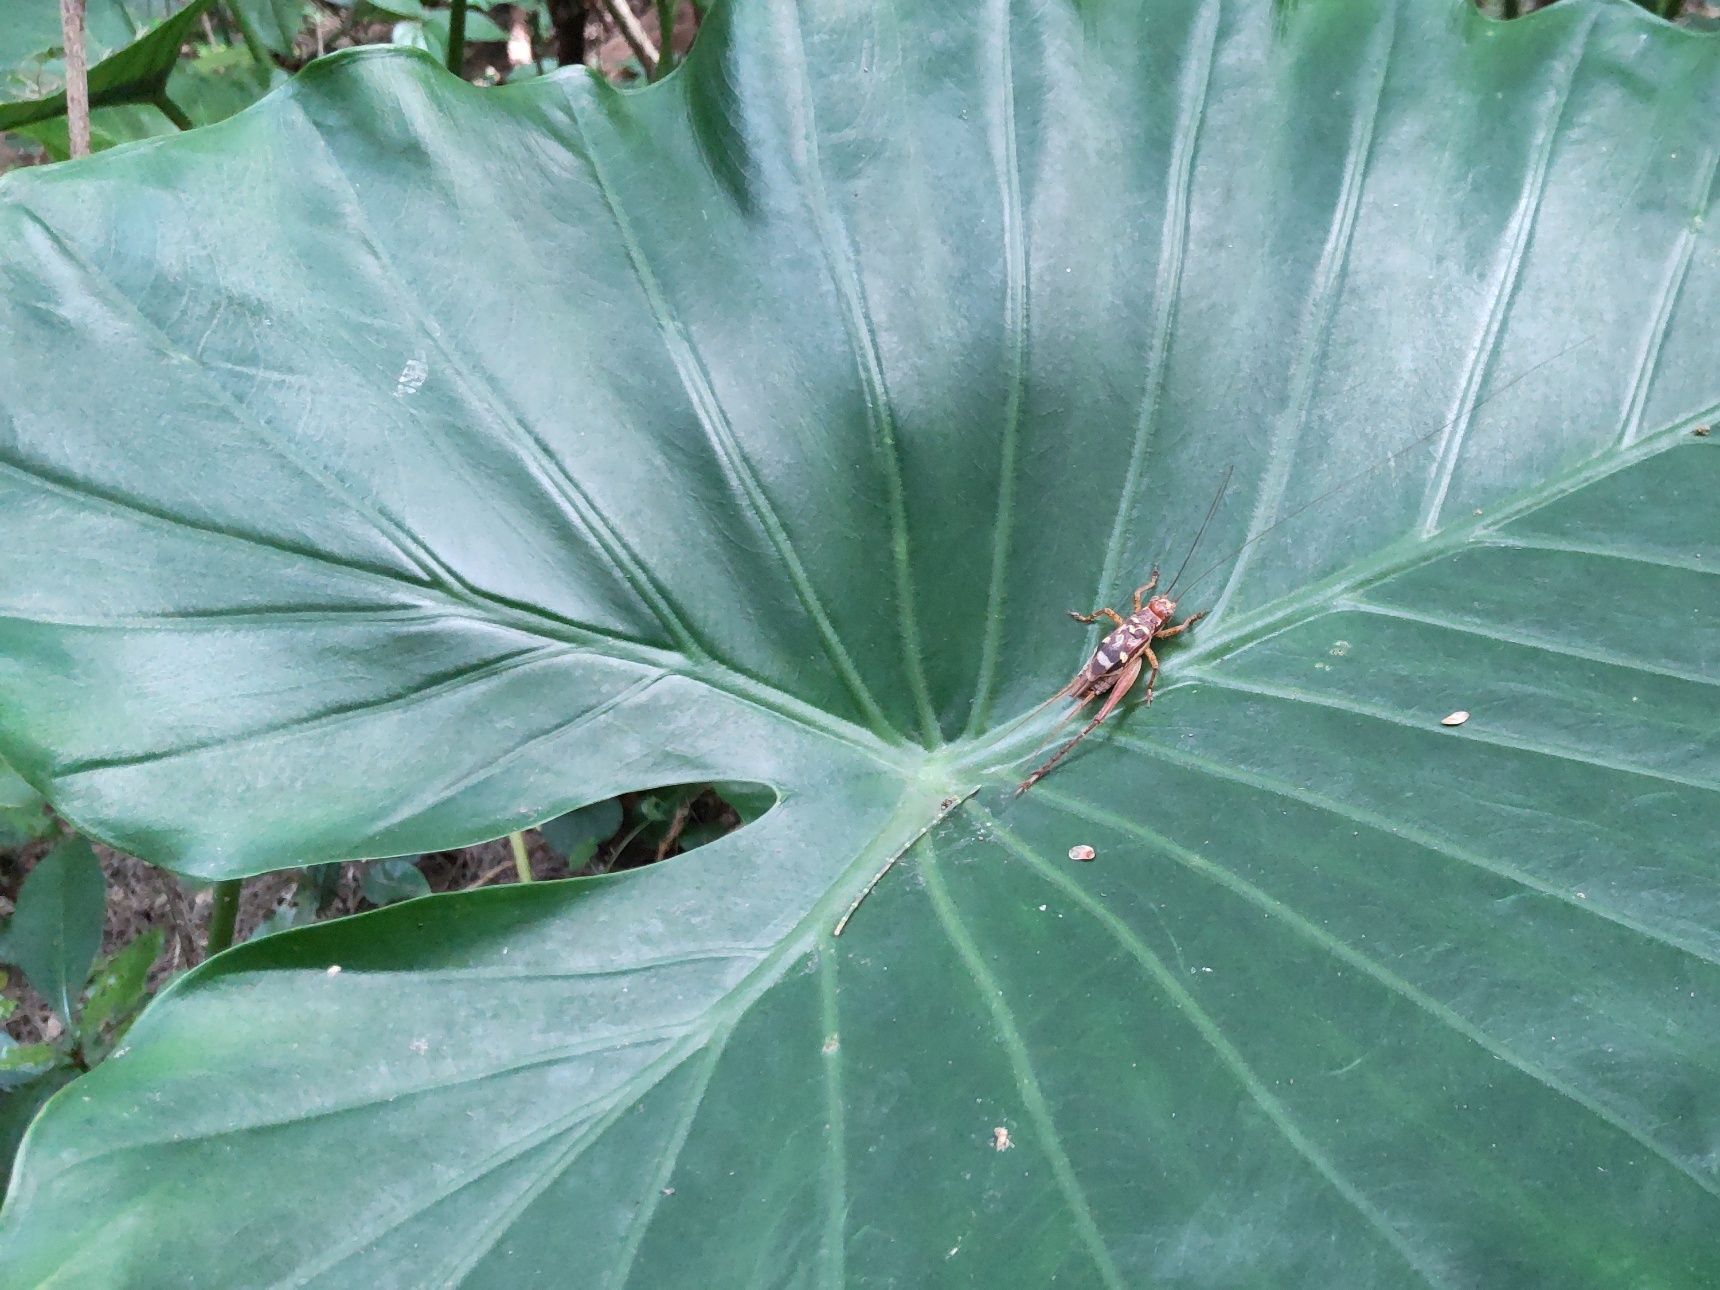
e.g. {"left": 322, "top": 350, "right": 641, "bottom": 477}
{"left": 5, "top": 838, "right": 107, "bottom": 1023}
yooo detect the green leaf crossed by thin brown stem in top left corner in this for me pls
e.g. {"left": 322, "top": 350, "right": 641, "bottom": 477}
{"left": 0, "top": 0, "right": 215, "bottom": 131}
